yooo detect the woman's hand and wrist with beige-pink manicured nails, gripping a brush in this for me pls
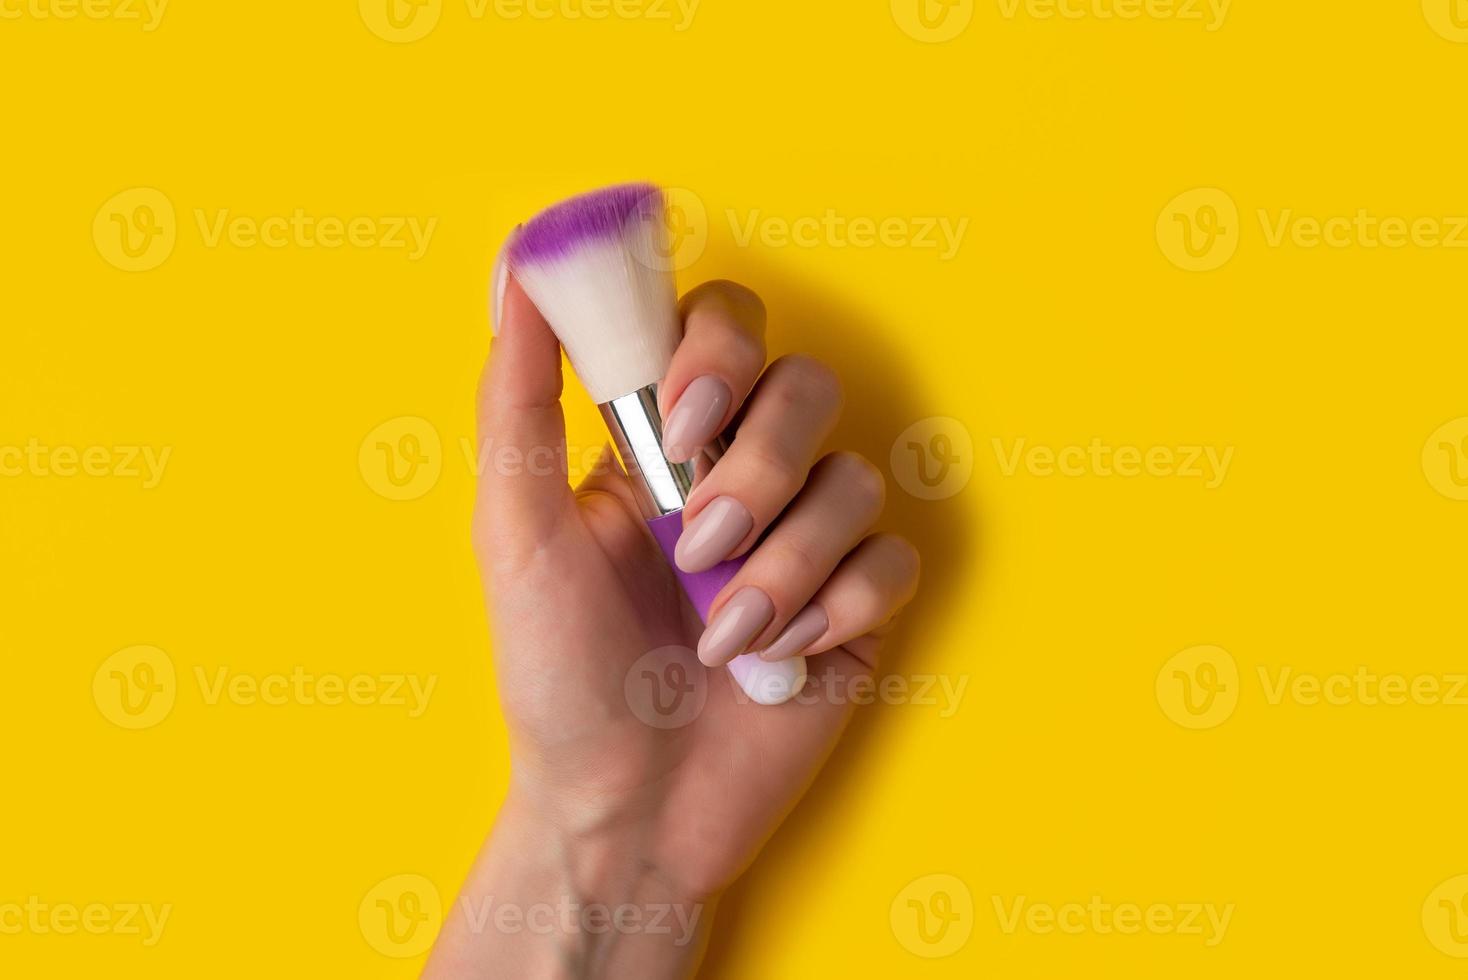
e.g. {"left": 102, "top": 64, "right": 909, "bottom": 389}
{"left": 426, "top": 282, "right": 918, "bottom": 979}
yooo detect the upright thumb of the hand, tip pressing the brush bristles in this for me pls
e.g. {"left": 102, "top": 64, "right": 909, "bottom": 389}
{"left": 476, "top": 268, "right": 575, "bottom": 555}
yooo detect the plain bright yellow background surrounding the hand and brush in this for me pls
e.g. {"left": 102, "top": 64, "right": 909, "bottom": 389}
{"left": 0, "top": 0, "right": 1468, "bottom": 977}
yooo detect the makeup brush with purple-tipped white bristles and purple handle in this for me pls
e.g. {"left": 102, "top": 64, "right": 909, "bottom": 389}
{"left": 505, "top": 183, "right": 806, "bottom": 704}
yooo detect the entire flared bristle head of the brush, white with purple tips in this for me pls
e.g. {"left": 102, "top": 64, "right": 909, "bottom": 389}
{"left": 506, "top": 183, "right": 683, "bottom": 403}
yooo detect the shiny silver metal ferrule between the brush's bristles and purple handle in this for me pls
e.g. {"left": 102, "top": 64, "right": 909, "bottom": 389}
{"left": 597, "top": 384, "right": 725, "bottom": 521}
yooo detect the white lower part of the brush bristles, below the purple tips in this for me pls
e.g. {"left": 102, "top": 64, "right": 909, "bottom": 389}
{"left": 509, "top": 214, "right": 683, "bottom": 403}
